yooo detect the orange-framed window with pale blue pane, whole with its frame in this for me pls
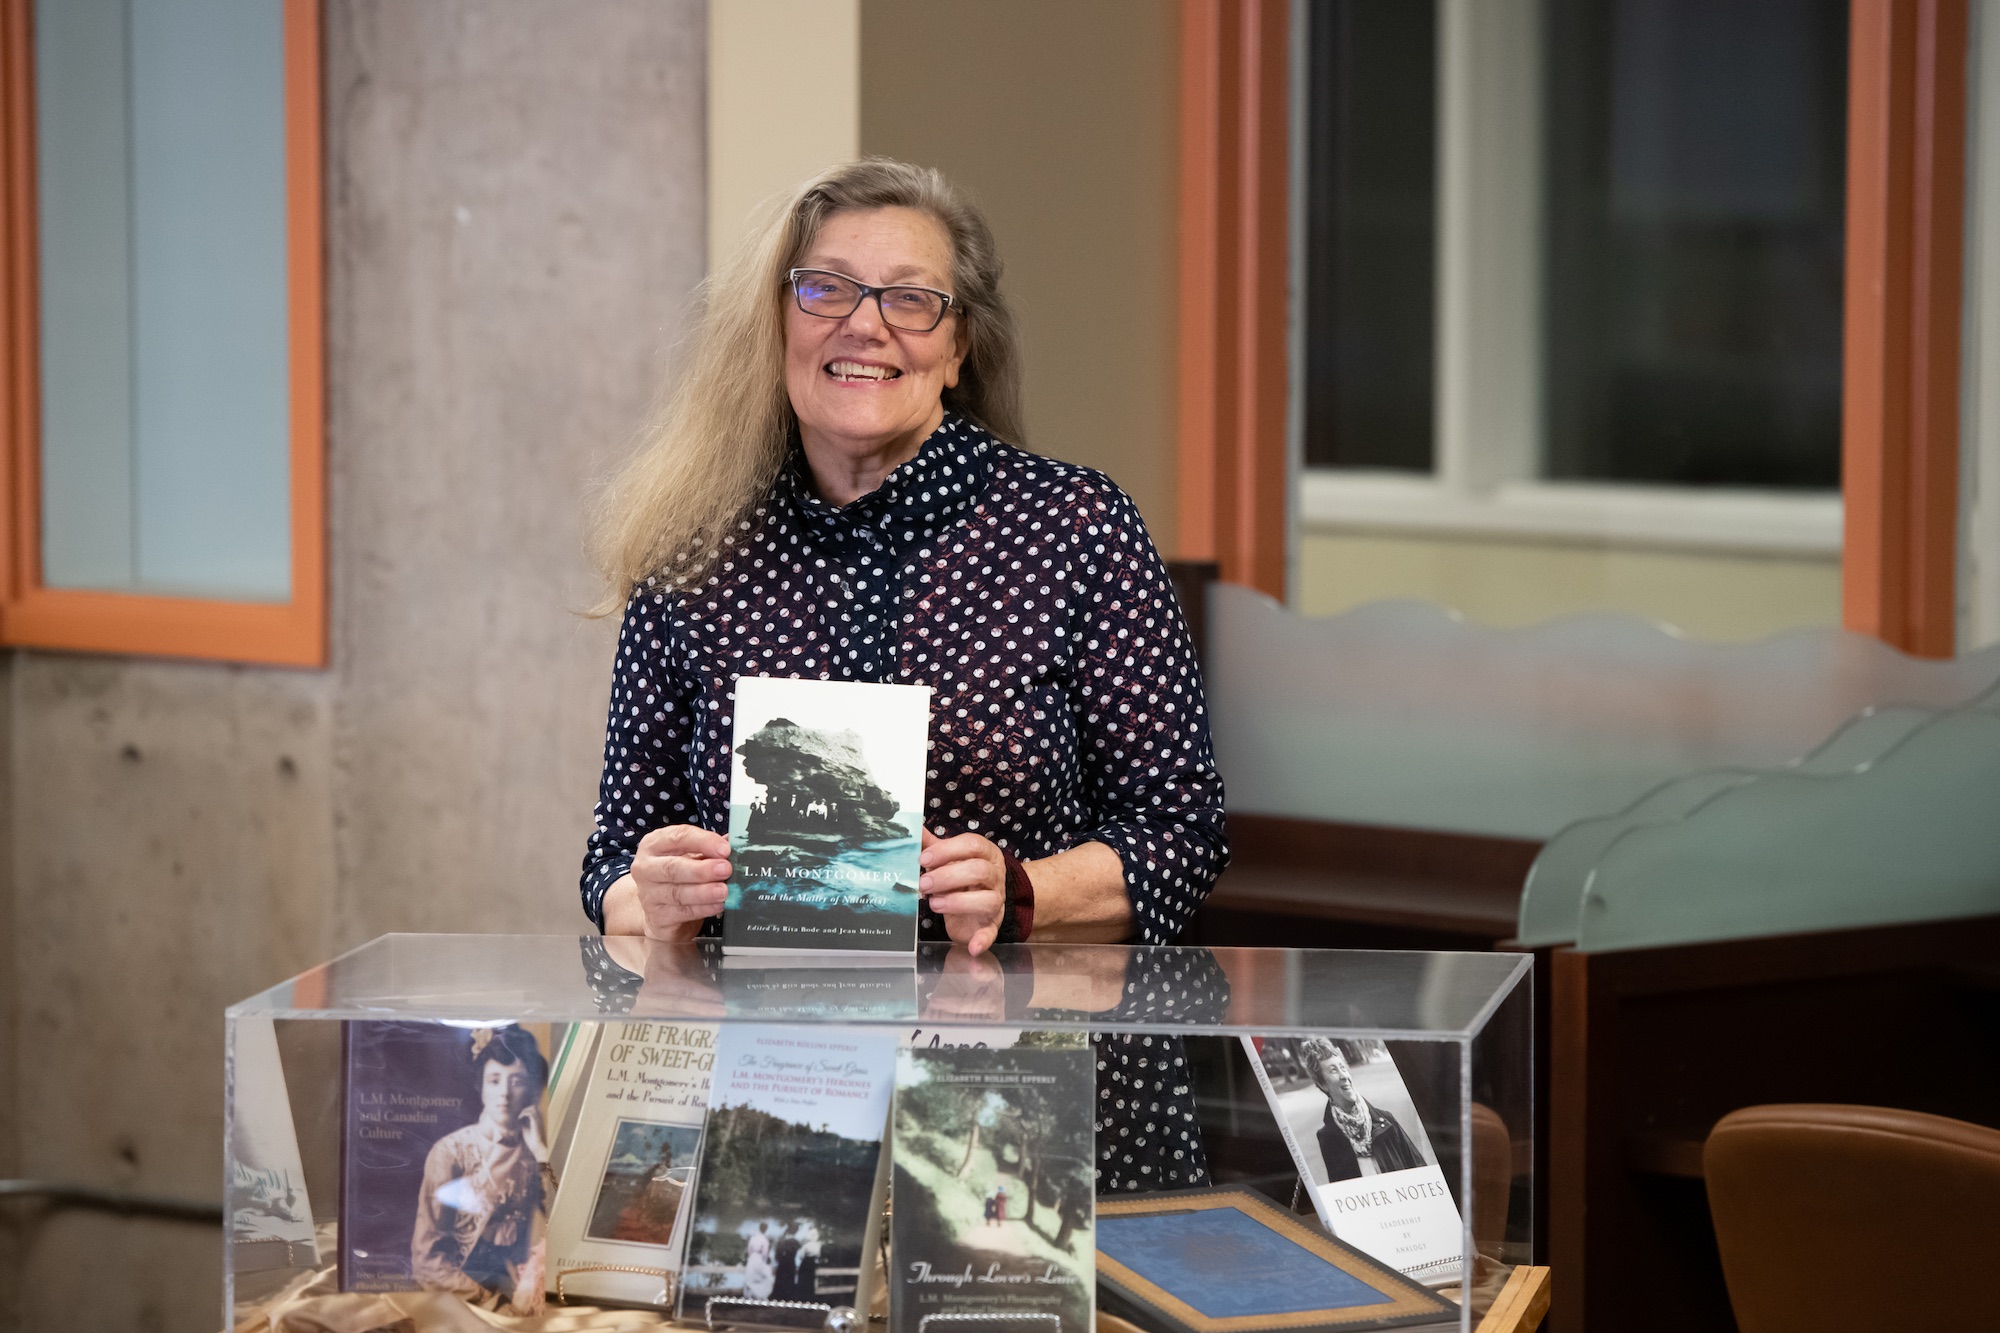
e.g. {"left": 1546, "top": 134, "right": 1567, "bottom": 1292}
{"left": 0, "top": 0, "right": 326, "bottom": 664}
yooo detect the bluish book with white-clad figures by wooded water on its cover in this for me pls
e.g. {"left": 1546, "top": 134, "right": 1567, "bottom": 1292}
{"left": 678, "top": 1023, "right": 896, "bottom": 1329}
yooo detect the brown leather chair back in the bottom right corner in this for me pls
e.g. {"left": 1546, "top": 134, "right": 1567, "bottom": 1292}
{"left": 1702, "top": 1105, "right": 2000, "bottom": 1333}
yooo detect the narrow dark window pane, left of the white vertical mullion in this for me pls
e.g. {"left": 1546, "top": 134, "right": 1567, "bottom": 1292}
{"left": 1306, "top": 0, "right": 1438, "bottom": 472}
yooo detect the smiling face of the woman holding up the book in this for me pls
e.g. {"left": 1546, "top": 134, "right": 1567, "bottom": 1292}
{"left": 784, "top": 208, "right": 964, "bottom": 472}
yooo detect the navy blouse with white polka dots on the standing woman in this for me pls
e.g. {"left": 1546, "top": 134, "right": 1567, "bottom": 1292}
{"left": 582, "top": 414, "right": 1228, "bottom": 1189}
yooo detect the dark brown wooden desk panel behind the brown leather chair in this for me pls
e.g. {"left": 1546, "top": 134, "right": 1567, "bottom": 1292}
{"left": 1540, "top": 917, "right": 2000, "bottom": 1333}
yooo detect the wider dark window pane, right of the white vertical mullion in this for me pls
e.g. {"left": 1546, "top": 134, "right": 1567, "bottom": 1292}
{"left": 1546, "top": 0, "right": 1848, "bottom": 488}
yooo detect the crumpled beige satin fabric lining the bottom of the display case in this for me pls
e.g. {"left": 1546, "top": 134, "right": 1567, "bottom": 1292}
{"left": 232, "top": 1269, "right": 672, "bottom": 1333}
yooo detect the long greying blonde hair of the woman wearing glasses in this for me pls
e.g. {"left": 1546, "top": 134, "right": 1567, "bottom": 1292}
{"left": 592, "top": 158, "right": 1022, "bottom": 614}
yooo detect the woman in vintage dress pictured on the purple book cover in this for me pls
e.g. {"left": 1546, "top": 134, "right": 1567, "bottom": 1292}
{"left": 410, "top": 1027, "right": 550, "bottom": 1315}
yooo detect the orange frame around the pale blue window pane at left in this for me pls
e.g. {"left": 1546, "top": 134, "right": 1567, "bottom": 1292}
{"left": 0, "top": 0, "right": 326, "bottom": 667}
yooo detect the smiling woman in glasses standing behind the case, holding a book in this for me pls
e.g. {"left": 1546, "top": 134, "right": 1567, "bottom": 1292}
{"left": 582, "top": 160, "right": 1228, "bottom": 1189}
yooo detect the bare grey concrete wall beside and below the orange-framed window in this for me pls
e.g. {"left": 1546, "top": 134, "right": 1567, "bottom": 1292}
{"left": 0, "top": 0, "right": 706, "bottom": 1333}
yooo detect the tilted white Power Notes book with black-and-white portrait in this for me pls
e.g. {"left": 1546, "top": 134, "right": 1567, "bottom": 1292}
{"left": 1244, "top": 1037, "right": 1464, "bottom": 1285}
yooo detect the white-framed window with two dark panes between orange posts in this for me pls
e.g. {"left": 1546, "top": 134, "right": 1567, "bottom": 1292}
{"left": 1294, "top": 0, "right": 1846, "bottom": 552}
